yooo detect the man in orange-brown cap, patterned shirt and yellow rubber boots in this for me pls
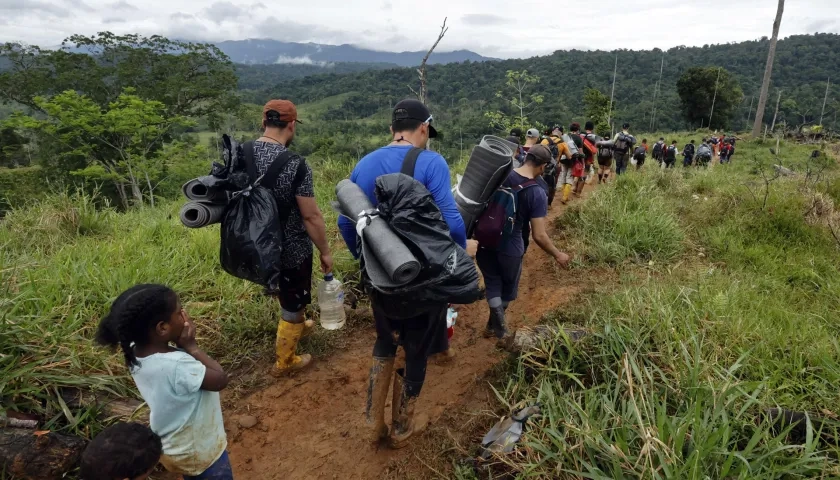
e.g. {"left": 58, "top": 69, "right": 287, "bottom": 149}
{"left": 249, "top": 100, "right": 333, "bottom": 374}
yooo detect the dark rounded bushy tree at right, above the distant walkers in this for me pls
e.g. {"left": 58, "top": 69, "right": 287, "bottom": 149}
{"left": 677, "top": 67, "right": 744, "bottom": 129}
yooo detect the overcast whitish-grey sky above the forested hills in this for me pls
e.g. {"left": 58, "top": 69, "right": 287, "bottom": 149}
{"left": 0, "top": 0, "right": 840, "bottom": 58}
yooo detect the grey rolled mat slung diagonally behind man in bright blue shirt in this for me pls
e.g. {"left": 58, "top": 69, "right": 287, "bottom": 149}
{"left": 335, "top": 179, "right": 422, "bottom": 288}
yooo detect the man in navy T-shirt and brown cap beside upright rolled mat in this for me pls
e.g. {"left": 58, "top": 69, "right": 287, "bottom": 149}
{"left": 476, "top": 145, "right": 569, "bottom": 339}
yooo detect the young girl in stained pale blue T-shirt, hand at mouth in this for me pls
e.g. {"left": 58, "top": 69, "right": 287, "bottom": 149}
{"left": 96, "top": 285, "right": 233, "bottom": 480}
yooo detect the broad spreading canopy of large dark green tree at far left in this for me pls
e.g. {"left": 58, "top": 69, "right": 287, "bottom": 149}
{"left": 0, "top": 32, "right": 236, "bottom": 116}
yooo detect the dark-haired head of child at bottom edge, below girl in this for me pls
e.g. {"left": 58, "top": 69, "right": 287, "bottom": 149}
{"left": 79, "top": 422, "right": 163, "bottom": 480}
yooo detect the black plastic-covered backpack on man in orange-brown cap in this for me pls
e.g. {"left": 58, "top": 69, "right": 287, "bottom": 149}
{"left": 219, "top": 142, "right": 306, "bottom": 294}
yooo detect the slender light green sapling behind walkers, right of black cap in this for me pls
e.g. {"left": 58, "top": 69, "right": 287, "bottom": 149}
{"left": 486, "top": 70, "right": 543, "bottom": 131}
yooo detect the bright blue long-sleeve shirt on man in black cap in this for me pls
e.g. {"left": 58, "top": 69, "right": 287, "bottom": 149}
{"left": 338, "top": 145, "right": 467, "bottom": 258}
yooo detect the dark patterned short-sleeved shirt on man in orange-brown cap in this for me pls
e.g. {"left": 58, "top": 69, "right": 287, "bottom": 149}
{"left": 254, "top": 140, "right": 315, "bottom": 269}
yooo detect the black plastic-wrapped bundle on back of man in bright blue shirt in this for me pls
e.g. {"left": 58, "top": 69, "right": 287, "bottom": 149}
{"left": 375, "top": 173, "right": 483, "bottom": 316}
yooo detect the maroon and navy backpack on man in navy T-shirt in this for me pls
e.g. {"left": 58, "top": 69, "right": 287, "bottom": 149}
{"left": 473, "top": 179, "right": 537, "bottom": 250}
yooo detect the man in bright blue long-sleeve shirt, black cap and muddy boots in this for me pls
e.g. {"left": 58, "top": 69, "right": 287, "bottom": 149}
{"left": 338, "top": 100, "right": 474, "bottom": 448}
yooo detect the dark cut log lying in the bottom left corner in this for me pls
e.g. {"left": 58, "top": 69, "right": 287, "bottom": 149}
{"left": 0, "top": 428, "right": 87, "bottom": 480}
